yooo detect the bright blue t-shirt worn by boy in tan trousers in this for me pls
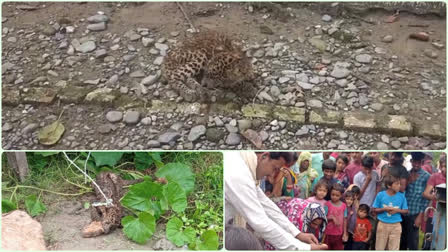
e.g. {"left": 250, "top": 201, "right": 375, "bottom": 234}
{"left": 373, "top": 191, "right": 408, "bottom": 224}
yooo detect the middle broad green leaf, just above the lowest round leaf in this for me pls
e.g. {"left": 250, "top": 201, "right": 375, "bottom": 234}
{"left": 121, "top": 181, "right": 163, "bottom": 211}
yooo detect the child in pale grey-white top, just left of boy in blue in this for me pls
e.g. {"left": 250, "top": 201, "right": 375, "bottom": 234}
{"left": 353, "top": 156, "right": 380, "bottom": 207}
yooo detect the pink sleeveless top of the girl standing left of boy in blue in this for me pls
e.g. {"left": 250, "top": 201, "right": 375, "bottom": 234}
{"left": 325, "top": 200, "right": 347, "bottom": 235}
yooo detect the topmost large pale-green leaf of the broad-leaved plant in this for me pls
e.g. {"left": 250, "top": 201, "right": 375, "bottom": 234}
{"left": 156, "top": 163, "right": 195, "bottom": 195}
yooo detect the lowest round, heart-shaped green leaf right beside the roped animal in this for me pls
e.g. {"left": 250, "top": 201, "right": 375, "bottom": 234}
{"left": 121, "top": 212, "right": 156, "bottom": 244}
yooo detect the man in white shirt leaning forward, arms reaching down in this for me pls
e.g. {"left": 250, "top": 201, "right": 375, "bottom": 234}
{"left": 224, "top": 151, "right": 327, "bottom": 250}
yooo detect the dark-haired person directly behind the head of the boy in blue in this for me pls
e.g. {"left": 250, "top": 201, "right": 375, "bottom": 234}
{"left": 381, "top": 152, "right": 409, "bottom": 192}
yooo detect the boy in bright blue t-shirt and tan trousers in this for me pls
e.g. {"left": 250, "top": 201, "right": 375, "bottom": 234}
{"left": 373, "top": 175, "right": 409, "bottom": 250}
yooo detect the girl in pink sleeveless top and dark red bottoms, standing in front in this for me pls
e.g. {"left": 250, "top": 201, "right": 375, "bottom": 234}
{"left": 324, "top": 183, "right": 348, "bottom": 250}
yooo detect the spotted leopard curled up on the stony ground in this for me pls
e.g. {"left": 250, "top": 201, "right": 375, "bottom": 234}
{"left": 162, "top": 30, "right": 256, "bottom": 102}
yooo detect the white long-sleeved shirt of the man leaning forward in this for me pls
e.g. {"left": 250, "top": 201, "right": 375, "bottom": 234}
{"left": 224, "top": 152, "right": 311, "bottom": 250}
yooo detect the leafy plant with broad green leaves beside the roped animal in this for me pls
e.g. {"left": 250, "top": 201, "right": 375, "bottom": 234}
{"left": 121, "top": 162, "right": 219, "bottom": 250}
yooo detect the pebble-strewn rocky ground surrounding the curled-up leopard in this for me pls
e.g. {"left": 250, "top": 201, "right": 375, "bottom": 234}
{"left": 2, "top": 2, "right": 446, "bottom": 150}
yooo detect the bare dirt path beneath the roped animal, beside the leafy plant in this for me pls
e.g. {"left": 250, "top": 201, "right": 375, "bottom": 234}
{"left": 38, "top": 197, "right": 183, "bottom": 250}
